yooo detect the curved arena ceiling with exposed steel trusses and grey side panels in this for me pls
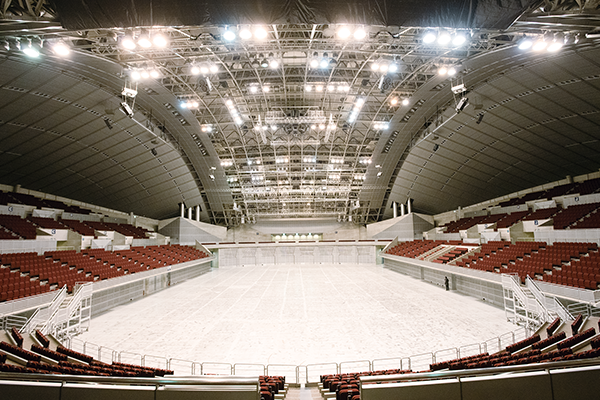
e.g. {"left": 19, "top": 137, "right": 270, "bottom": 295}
{"left": 0, "top": 1, "right": 600, "bottom": 226}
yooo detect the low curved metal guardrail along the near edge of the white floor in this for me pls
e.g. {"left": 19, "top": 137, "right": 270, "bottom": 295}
{"left": 64, "top": 328, "right": 529, "bottom": 384}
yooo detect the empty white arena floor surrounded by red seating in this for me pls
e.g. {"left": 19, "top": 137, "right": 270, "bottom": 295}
{"left": 79, "top": 265, "right": 517, "bottom": 365}
